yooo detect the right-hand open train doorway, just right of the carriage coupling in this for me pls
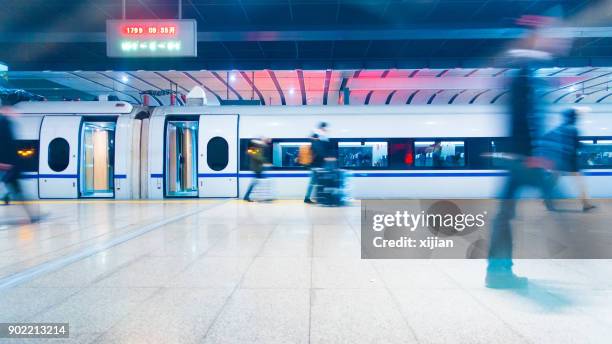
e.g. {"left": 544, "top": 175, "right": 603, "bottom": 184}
{"left": 164, "top": 117, "right": 199, "bottom": 197}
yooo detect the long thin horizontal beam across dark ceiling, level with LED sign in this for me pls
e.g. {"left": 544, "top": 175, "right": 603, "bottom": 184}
{"left": 0, "top": 26, "right": 612, "bottom": 43}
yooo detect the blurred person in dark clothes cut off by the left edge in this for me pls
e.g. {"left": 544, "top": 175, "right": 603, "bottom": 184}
{"left": 0, "top": 114, "right": 40, "bottom": 223}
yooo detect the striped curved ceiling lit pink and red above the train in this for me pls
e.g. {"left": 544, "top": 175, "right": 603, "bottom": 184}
{"left": 9, "top": 67, "right": 612, "bottom": 105}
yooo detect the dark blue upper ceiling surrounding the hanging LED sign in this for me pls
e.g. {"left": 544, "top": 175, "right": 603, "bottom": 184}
{"left": 0, "top": 0, "right": 612, "bottom": 71}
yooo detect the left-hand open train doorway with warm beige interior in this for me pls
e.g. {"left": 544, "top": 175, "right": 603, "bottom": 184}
{"left": 79, "top": 118, "right": 116, "bottom": 198}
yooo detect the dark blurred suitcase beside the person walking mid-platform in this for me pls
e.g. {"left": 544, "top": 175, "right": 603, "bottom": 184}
{"left": 315, "top": 167, "right": 346, "bottom": 206}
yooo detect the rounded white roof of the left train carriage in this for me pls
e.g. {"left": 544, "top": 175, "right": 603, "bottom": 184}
{"left": 3, "top": 101, "right": 135, "bottom": 115}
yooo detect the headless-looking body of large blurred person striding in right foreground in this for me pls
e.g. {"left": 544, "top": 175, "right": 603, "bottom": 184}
{"left": 486, "top": 65, "right": 552, "bottom": 288}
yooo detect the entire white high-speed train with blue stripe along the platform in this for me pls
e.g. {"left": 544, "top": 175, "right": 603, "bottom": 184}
{"left": 3, "top": 102, "right": 612, "bottom": 199}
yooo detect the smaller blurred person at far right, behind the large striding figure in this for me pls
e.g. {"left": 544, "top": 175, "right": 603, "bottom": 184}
{"left": 547, "top": 108, "right": 595, "bottom": 212}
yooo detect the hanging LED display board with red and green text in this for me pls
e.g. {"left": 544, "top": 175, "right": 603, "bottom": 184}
{"left": 106, "top": 19, "right": 198, "bottom": 57}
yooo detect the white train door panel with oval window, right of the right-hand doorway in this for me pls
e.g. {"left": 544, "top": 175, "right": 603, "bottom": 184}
{"left": 198, "top": 115, "right": 238, "bottom": 197}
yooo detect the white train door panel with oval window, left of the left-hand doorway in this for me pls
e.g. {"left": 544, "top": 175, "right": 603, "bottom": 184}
{"left": 38, "top": 116, "right": 81, "bottom": 198}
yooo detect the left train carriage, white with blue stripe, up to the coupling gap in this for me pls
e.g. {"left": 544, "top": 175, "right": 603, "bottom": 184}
{"left": 2, "top": 102, "right": 150, "bottom": 199}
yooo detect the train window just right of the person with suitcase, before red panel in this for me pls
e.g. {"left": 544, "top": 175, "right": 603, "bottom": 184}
{"left": 338, "top": 141, "right": 389, "bottom": 168}
